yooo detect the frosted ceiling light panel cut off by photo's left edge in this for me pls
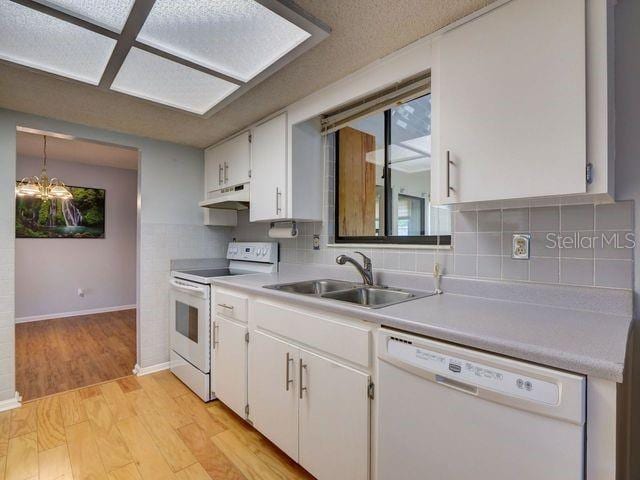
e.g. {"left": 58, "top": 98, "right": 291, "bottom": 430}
{"left": 0, "top": 0, "right": 116, "bottom": 85}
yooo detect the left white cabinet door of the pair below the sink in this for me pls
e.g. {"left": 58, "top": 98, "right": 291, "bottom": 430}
{"left": 249, "top": 332, "right": 299, "bottom": 461}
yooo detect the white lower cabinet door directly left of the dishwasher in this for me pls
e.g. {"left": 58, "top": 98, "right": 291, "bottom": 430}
{"left": 298, "top": 350, "right": 370, "bottom": 480}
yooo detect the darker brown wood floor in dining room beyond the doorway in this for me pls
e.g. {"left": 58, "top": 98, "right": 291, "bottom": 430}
{"left": 16, "top": 309, "right": 136, "bottom": 401}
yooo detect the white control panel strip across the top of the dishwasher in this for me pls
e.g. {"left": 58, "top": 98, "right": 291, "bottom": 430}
{"left": 387, "top": 337, "right": 560, "bottom": 405}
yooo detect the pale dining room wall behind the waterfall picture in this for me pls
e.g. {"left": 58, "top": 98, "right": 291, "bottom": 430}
{"left": 15, "top": 157, "right": 138, "bottom": 319}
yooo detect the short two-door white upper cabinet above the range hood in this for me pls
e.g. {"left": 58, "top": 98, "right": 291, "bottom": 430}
{"left": 204, "top": 131, "right": 251, "bottom": 194}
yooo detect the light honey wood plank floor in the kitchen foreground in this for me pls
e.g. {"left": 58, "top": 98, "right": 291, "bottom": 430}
{"left": 0, "top": 371, "right": 313, "bottom": 480}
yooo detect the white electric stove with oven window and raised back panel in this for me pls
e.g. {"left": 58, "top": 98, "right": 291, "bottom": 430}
{"left": 169, "top": 242, "right": 278, "bottom": 402}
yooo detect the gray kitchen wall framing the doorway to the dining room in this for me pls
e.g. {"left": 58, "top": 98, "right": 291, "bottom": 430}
{"left": 0, "top": 109, "right": 229, "bottom": 401}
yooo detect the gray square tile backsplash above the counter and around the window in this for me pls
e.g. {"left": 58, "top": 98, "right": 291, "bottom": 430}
{"left": 233, "top": 131, "right": 633, "bottom": 289}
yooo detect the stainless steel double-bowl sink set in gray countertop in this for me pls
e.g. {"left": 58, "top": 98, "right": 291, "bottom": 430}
{"left": 264, "top": 279, "right": 433, "bottom": 308}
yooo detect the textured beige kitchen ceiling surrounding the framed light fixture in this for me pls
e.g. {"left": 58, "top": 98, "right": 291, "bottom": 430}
{"left": 0, "top": 0, "right": 493, "bottom": 147}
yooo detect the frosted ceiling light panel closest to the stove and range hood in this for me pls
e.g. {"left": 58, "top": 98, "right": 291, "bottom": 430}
{"left": 111, "top": 47, "right": 238, "bottom": 115}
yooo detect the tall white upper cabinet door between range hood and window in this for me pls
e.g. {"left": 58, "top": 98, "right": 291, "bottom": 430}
{"left": 249, "top": 113, "right": 287, "bottom": 222}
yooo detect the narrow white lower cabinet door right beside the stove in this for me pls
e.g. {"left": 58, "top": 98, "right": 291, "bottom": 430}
{"left": 211, "top": 316, "right": 248, "bottom": 418}
